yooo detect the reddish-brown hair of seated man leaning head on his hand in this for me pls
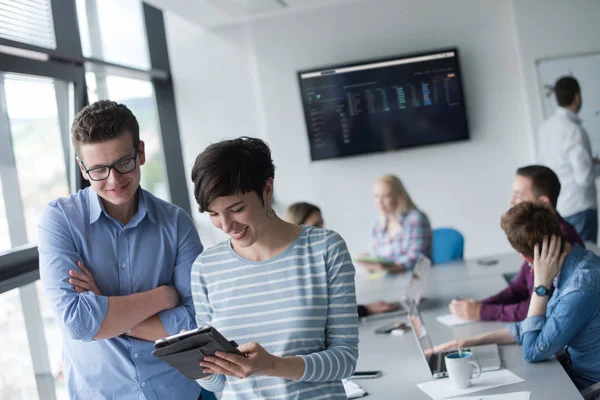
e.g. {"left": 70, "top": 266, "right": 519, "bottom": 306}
{"left": 500, "top": 201, "right": 564, "bottom": 258}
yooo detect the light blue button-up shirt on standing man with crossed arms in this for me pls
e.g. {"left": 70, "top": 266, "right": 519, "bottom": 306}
{"left": 38, "top": 188, "right": 202, "bottom": 400}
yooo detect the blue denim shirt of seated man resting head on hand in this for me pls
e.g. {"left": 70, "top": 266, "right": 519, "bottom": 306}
{"left": 509, "top": 245, "right": 600, "bottom": 390}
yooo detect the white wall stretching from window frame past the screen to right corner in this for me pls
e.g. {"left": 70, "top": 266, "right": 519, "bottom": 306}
{"left": 167, "top": 0, "right": 532, "bottom": 257}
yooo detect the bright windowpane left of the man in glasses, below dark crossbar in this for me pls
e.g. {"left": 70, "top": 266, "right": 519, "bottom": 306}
{"left": 4, "top": 74, "right": 69, "bottom": 245}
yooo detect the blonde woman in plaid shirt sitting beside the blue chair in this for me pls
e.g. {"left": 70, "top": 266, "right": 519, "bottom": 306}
{"left": 359, "top": 175, "right": 432, "bottom": 273}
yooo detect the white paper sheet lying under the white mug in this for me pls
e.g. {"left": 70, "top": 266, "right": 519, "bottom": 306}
{"left": 417, "top": 369, "right": 523, "bottom": 400}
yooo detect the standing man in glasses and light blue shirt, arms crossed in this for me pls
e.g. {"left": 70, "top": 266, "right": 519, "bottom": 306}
{"left": 38, "top": 100, "right": 202, "bottom": 400}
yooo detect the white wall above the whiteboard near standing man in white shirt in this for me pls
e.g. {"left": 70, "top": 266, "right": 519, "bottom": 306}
{"left": 513, "top": 0, "right": 600, "bottom": 148}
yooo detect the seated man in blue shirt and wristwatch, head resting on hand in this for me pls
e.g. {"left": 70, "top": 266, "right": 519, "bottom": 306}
{"left": 435, "top": 202, "right": 600, "bottom": 390}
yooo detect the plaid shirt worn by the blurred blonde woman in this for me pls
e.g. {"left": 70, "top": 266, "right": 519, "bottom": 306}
{"left": 369, "top": 209, "right": 432, "bottom": 269}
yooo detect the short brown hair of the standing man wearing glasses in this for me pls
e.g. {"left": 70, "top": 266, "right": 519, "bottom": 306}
{"left": 71, "top": 100, "right": 140, "bottom": 152}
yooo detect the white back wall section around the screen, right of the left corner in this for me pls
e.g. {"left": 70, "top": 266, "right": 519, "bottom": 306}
{"left": 247, "top": 0, "right": 532, "bottom": 257}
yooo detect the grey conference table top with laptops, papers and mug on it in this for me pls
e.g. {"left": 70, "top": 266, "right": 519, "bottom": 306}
{"left": 356, "top": 253, "right": 582, "bottom": 400}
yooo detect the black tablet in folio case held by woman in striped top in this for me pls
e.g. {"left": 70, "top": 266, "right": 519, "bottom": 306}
{"left": 152, "top": 326, "right": 244, "bottom": 379}
